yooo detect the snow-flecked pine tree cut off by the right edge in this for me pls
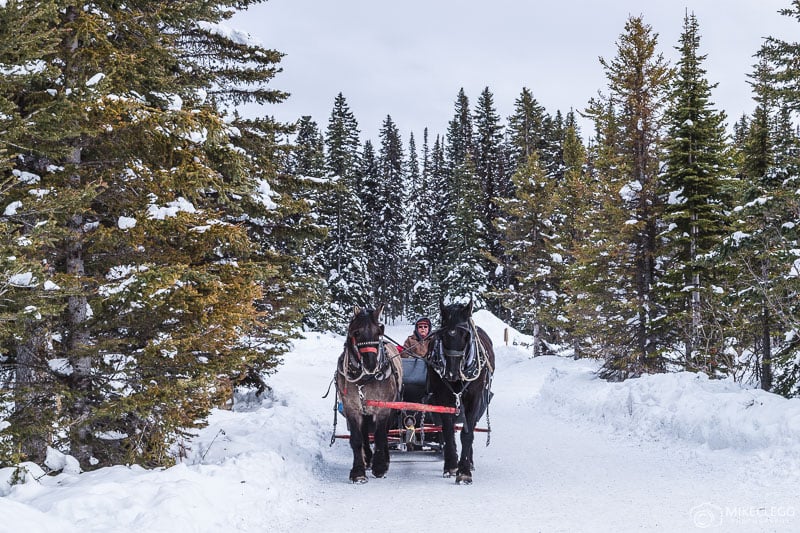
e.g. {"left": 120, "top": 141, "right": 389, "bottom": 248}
{"left": 728, "top": 54, "right": 800, "bottom": 395}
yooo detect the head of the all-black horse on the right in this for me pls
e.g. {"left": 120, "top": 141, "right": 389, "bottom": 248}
{"left": 431, "top": 298, "right": 477, "bottom": 381}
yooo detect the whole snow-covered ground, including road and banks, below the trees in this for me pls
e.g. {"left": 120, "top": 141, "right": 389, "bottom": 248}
{"left": 0, "top": 313, "right": 800, "bottom": 533}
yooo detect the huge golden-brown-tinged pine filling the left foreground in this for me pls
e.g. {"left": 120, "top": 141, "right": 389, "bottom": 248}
{"left": 0, "top": 2, "right": 302, "bottom": 468}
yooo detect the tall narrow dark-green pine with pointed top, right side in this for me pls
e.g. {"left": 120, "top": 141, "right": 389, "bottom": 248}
{"left": 659, "top": 14, "right": 733, "bottom": 370}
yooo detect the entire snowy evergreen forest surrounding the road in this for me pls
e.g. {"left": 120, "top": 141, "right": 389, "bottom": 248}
{"left": 0, "top": 0, "right": 800, "bottom": 469}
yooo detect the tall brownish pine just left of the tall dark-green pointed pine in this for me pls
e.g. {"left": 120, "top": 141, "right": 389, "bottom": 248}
{"left": 578, "top": 17, "right": 671, "bottom": 379}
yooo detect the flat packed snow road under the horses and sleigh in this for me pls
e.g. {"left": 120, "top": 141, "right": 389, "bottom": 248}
{"left": 274, "top": 318, "right": 800, "bottom": 532}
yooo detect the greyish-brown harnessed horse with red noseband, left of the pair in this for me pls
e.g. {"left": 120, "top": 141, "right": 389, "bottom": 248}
{"left": 336, "top": 307, "right": 403, "bottom": 483}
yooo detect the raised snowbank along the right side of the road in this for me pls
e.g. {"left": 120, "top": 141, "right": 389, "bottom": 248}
{"left": 539, "top": 362, "right": 800, "bottom": 451}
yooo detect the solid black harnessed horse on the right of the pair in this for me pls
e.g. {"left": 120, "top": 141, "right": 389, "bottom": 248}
{"left": 427, "top": 299, "right": 494, "bottom": 484}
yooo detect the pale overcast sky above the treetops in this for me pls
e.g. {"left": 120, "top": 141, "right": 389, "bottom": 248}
{"left": 232, "top": 0, "right": 800, "bottom": 142}
